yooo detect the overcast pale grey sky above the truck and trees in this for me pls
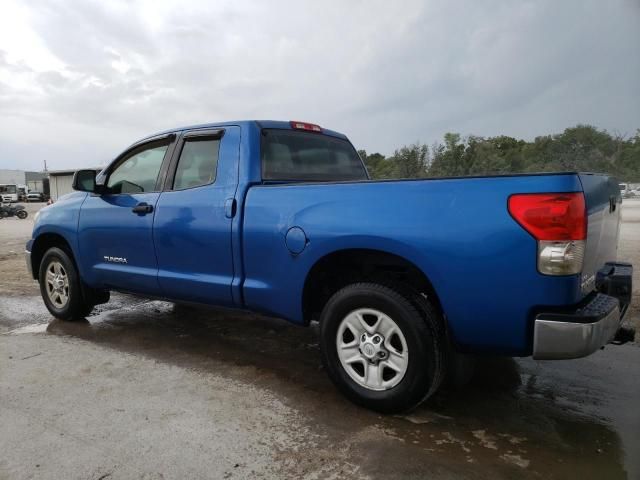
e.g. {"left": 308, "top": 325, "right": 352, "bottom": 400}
{"left": 0, "top": 0, "right": 640, "bottom": 169}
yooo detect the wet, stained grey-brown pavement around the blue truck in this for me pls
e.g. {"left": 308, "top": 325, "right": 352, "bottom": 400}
{"left": 0, "top": 200, "right": 640, "bottom": 479}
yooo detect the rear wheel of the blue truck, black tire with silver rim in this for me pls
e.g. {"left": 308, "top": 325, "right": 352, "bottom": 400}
{"left": 320, "top": 283, "right": 445, "bottom": 413}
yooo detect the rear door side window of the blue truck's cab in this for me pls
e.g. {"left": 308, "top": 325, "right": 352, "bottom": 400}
{"left": 173, "top": 137, "right": 220, "bottom": 190}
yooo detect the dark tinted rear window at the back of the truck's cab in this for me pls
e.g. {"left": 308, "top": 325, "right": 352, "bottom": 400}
{"left": 262, "top": 129, "right": 367, "bottom": 182}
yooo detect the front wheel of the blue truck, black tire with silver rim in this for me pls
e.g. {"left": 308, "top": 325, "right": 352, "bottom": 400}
{"left": 38, "top": 247, "right": 93, "bottom": 320}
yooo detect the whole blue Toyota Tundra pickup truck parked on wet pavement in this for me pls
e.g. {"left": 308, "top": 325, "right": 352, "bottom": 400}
{"left": 26, "top": 121, "right": 632, "bottom": 412}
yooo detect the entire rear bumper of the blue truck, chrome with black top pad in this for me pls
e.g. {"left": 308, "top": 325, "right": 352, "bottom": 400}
{"left": 533, "top": 264, "right": 633, "bottom": 360}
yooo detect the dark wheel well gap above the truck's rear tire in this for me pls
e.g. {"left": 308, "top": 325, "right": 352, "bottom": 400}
{"left": 302, "top": 249, "right": 443, "bottom": 323}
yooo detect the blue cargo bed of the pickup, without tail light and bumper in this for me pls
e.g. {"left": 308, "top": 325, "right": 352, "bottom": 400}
{"left": 243, "top": 172, "right": 618, "bottom": 355}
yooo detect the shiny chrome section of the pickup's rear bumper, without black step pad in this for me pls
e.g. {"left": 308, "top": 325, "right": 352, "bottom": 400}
{"left": 533, "top": 302, "right": 620, "bottom": 360}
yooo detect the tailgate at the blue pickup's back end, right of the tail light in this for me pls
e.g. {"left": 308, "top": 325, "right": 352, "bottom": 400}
{"left": 579, "top": 173, "right": 622, "bottom": 295}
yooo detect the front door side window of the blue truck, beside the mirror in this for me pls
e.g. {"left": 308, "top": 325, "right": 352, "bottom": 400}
{"left": 107, "top": 144, "right": 168, "bottom": 193}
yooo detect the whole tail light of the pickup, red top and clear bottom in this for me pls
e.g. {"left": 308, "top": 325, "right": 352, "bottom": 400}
{"left": 509, "top": 193, "right": 587, "bottom": 275}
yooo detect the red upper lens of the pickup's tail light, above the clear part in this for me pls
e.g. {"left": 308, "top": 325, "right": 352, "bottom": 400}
{"left": 509, "top": 193, "right": 587, "bottom": 241}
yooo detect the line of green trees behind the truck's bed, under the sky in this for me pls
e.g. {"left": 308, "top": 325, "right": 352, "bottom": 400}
{"left": 358, "top": 125, "right": 640, "bottom": 182}
